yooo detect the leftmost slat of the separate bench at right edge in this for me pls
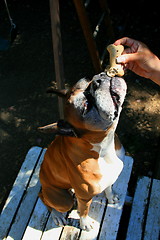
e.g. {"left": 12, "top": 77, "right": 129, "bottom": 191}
{"left": 126, "top": 177, "right": 151, "bottom": 240}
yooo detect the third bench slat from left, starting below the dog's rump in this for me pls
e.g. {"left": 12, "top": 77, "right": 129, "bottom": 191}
{"left": 22, "top": 198, "right": 49, "bottom": 240}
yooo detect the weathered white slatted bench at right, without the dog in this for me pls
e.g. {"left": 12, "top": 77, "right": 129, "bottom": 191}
{"left": 126, "top": 177, "right": 160, "bottom": 240}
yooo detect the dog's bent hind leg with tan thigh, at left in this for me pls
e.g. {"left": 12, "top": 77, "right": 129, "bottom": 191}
{"left": 39, "top": 186, "right": 74, "bottom": 226}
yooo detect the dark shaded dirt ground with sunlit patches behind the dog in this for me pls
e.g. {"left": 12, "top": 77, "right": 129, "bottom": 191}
{"left": 0, "top": 0, "right": 160, "bottom": 213}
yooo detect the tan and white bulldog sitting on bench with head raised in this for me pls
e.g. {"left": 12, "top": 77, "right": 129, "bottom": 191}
{"left": 40, "top": 72, "right": 126, "bottom": 231}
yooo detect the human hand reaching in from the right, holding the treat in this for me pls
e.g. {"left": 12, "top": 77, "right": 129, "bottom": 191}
{"left": 114, "top": 37, "right": 160, "bottom": 84}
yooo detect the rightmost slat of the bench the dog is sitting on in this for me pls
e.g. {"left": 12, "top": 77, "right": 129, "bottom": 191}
{"left": 99, "top": 156, "right": 133, "bottom": 240}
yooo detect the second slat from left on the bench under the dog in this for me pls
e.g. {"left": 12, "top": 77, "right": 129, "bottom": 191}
{"left": 7, "top": 150, "right": 45, "bottom": 240}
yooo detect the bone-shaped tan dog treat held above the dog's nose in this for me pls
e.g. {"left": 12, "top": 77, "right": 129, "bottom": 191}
{"left": 105, "top": 44, "right": 124, "bottom": 77}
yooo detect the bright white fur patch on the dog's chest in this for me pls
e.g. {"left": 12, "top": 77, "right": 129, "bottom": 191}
{"left": 92, "top": 132, "right": 124, "bottom": 192}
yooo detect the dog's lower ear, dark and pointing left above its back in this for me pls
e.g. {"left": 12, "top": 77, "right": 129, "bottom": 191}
{"left": 38, "top": 120, "right": 78, "bottom": 137}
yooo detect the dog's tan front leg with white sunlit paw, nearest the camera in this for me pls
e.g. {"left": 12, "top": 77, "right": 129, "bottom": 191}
{"left": 77, "top": 199, "right": 94, "bottom": 231}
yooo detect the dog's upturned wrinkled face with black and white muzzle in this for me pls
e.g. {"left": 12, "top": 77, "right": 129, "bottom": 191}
{"left": 66, "top": 72, "right": 127, "bottom": 130}
